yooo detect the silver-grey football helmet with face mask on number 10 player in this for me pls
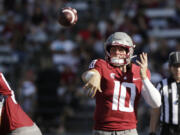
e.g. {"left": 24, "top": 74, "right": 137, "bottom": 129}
{"left": 104, "top": 32, "right": 135, "bottom": 66}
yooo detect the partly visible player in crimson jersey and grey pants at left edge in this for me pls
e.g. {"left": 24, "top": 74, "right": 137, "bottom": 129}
{"left": 0, "top": 73, "right": 41, "bottom": 135}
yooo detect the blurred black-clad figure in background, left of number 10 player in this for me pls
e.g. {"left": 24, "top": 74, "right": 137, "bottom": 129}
{"left": 35, "top": 56, "right": 61, "bottom": 132}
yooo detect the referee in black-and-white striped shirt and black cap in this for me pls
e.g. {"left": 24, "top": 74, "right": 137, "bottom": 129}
{"left": 149, "top": 52, "right": 180, "bottom": 135}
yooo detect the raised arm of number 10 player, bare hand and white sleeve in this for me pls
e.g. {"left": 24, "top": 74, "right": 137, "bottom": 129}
{"left": 137, "top": 53, "right": 161, "bottom": 108}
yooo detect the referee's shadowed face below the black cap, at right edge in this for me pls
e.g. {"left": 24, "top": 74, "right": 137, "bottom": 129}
{"left": 170, "top": 64, "right": 180, "bottom": 82}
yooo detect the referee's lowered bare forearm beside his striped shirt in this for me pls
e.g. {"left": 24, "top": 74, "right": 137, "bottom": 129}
{"left": 149, "top": 108, "right": 160, "bottom": 135}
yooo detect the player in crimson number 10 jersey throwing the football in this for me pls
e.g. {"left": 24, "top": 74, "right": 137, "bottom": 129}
{"left": 82, "top": 32, "right": 161, "bottom": 135}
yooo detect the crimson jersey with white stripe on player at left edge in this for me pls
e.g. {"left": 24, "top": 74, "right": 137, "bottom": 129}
{"left": 0, "top": 73, "right": 33, "bottom": 134}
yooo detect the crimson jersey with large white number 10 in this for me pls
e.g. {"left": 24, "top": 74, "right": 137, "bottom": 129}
{"left": 89, "top": 59, "right": 150, "bottom": 131}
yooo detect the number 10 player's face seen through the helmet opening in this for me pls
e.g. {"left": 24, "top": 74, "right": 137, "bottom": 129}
{"left": 110, "top": 46, "right": 126, "bottom": 58}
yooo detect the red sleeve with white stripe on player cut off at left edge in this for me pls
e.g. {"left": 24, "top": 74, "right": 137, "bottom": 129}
{"left": 0, "top": 73, "right": 11, "bottom": 96}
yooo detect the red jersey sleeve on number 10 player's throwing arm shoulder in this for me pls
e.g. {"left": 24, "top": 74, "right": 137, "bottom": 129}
{"left": 89, "top": 59, "right": 102, "bottom": 75}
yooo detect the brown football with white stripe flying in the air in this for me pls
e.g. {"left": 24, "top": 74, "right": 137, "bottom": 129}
{"left": 58, "top": 7, "right": 78, "bottom": 27}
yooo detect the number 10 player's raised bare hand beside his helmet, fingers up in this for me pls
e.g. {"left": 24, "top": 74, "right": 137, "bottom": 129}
{"left": 136, "top": 52, "right": 148, "bottom": 79}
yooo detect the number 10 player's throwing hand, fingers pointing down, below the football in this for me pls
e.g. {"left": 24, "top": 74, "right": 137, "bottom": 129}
{"left": 84, "top": 71, "right": 102, "bottom": 98}
